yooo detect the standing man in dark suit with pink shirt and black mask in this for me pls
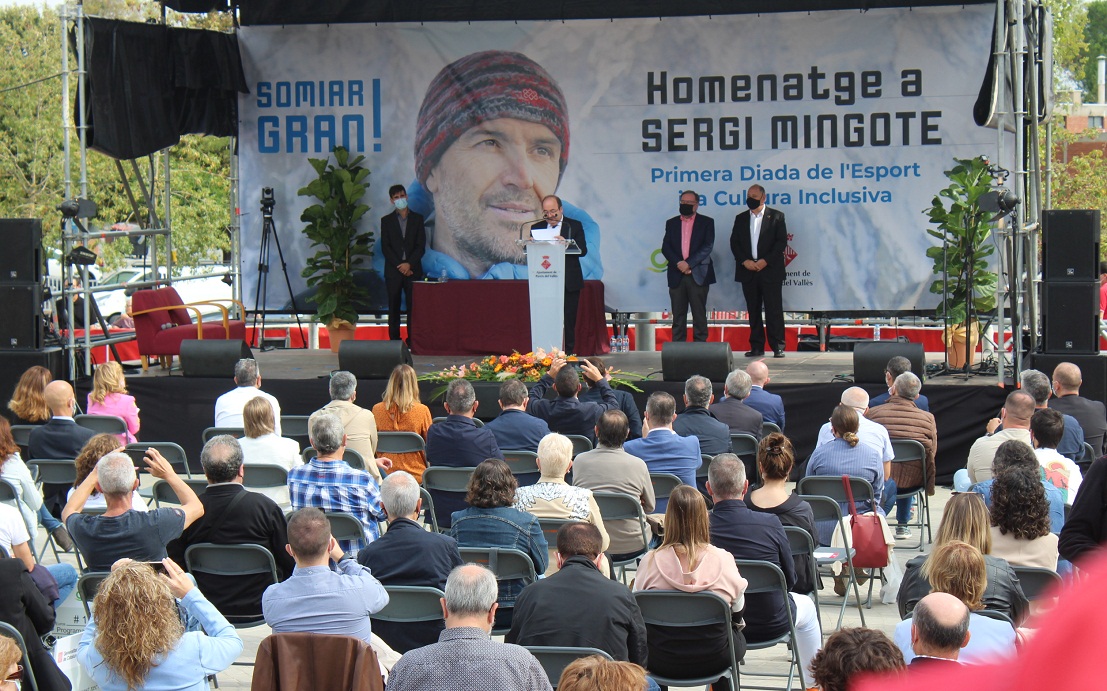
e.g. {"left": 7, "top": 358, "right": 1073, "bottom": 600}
{"left": 661, "top": 189, "right": 715, "bottom": 341}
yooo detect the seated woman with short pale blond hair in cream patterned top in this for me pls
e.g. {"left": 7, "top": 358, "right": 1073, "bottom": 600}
{"left": 515, "top": 433, "right": 609, "bottom": 576}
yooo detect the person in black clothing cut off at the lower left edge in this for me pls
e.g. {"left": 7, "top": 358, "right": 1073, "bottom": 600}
{"left": 0, "top": 556, "right": 71, "bottom": 691}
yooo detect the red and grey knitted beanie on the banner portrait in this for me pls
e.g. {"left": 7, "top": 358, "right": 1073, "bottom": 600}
{"left": 415, "top": 51, "right": 569, "bottom": 183}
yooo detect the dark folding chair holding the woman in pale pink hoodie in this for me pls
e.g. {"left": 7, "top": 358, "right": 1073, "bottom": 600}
{"left": 634, "top": 589, "right": 743, "bottom": 689}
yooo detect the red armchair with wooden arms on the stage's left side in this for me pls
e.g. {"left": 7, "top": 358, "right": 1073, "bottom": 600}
{"left": 131, "top": 286, "right": 246, "bottom": 370}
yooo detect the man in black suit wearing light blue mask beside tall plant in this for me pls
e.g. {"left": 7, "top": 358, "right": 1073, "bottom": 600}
{"left": 381, "top": 185, "right": 426, "bottom": 343}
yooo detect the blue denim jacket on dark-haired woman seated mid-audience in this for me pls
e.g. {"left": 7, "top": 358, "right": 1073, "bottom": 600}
{"left": 449, "top": 506, "right": 549, "bottom": 607}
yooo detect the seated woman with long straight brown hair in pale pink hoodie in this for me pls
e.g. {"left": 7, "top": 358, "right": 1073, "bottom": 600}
{"left": 634, "top": 485, "right": 747, "bottom": 688}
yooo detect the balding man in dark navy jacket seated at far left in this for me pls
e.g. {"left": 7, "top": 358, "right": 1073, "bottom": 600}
{"left": 27, "top": 380, "right": 95, "bottom": 551}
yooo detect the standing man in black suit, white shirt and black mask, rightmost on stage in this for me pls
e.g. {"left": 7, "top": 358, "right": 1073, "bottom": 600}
{"left": 731, "top": 185, "right": 788, "bottom": 358}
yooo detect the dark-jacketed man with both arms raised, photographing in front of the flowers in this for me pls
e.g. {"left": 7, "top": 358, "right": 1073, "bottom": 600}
{"left": 527, "top": 358, "right": 619, "bottom": 445}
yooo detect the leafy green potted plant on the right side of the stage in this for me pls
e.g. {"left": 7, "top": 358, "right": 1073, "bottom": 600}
{"left": 923, "top": 157, "right": 999, "bottom": 369}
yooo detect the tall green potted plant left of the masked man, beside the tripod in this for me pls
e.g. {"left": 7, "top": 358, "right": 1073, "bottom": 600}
{"left": 299, "top": 146, "right": 373, "bottom": 352}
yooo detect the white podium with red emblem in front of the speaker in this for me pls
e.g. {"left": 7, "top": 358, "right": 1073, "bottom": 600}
{"left": 524, "top": 239, "right": 580, "bottom": 351}
